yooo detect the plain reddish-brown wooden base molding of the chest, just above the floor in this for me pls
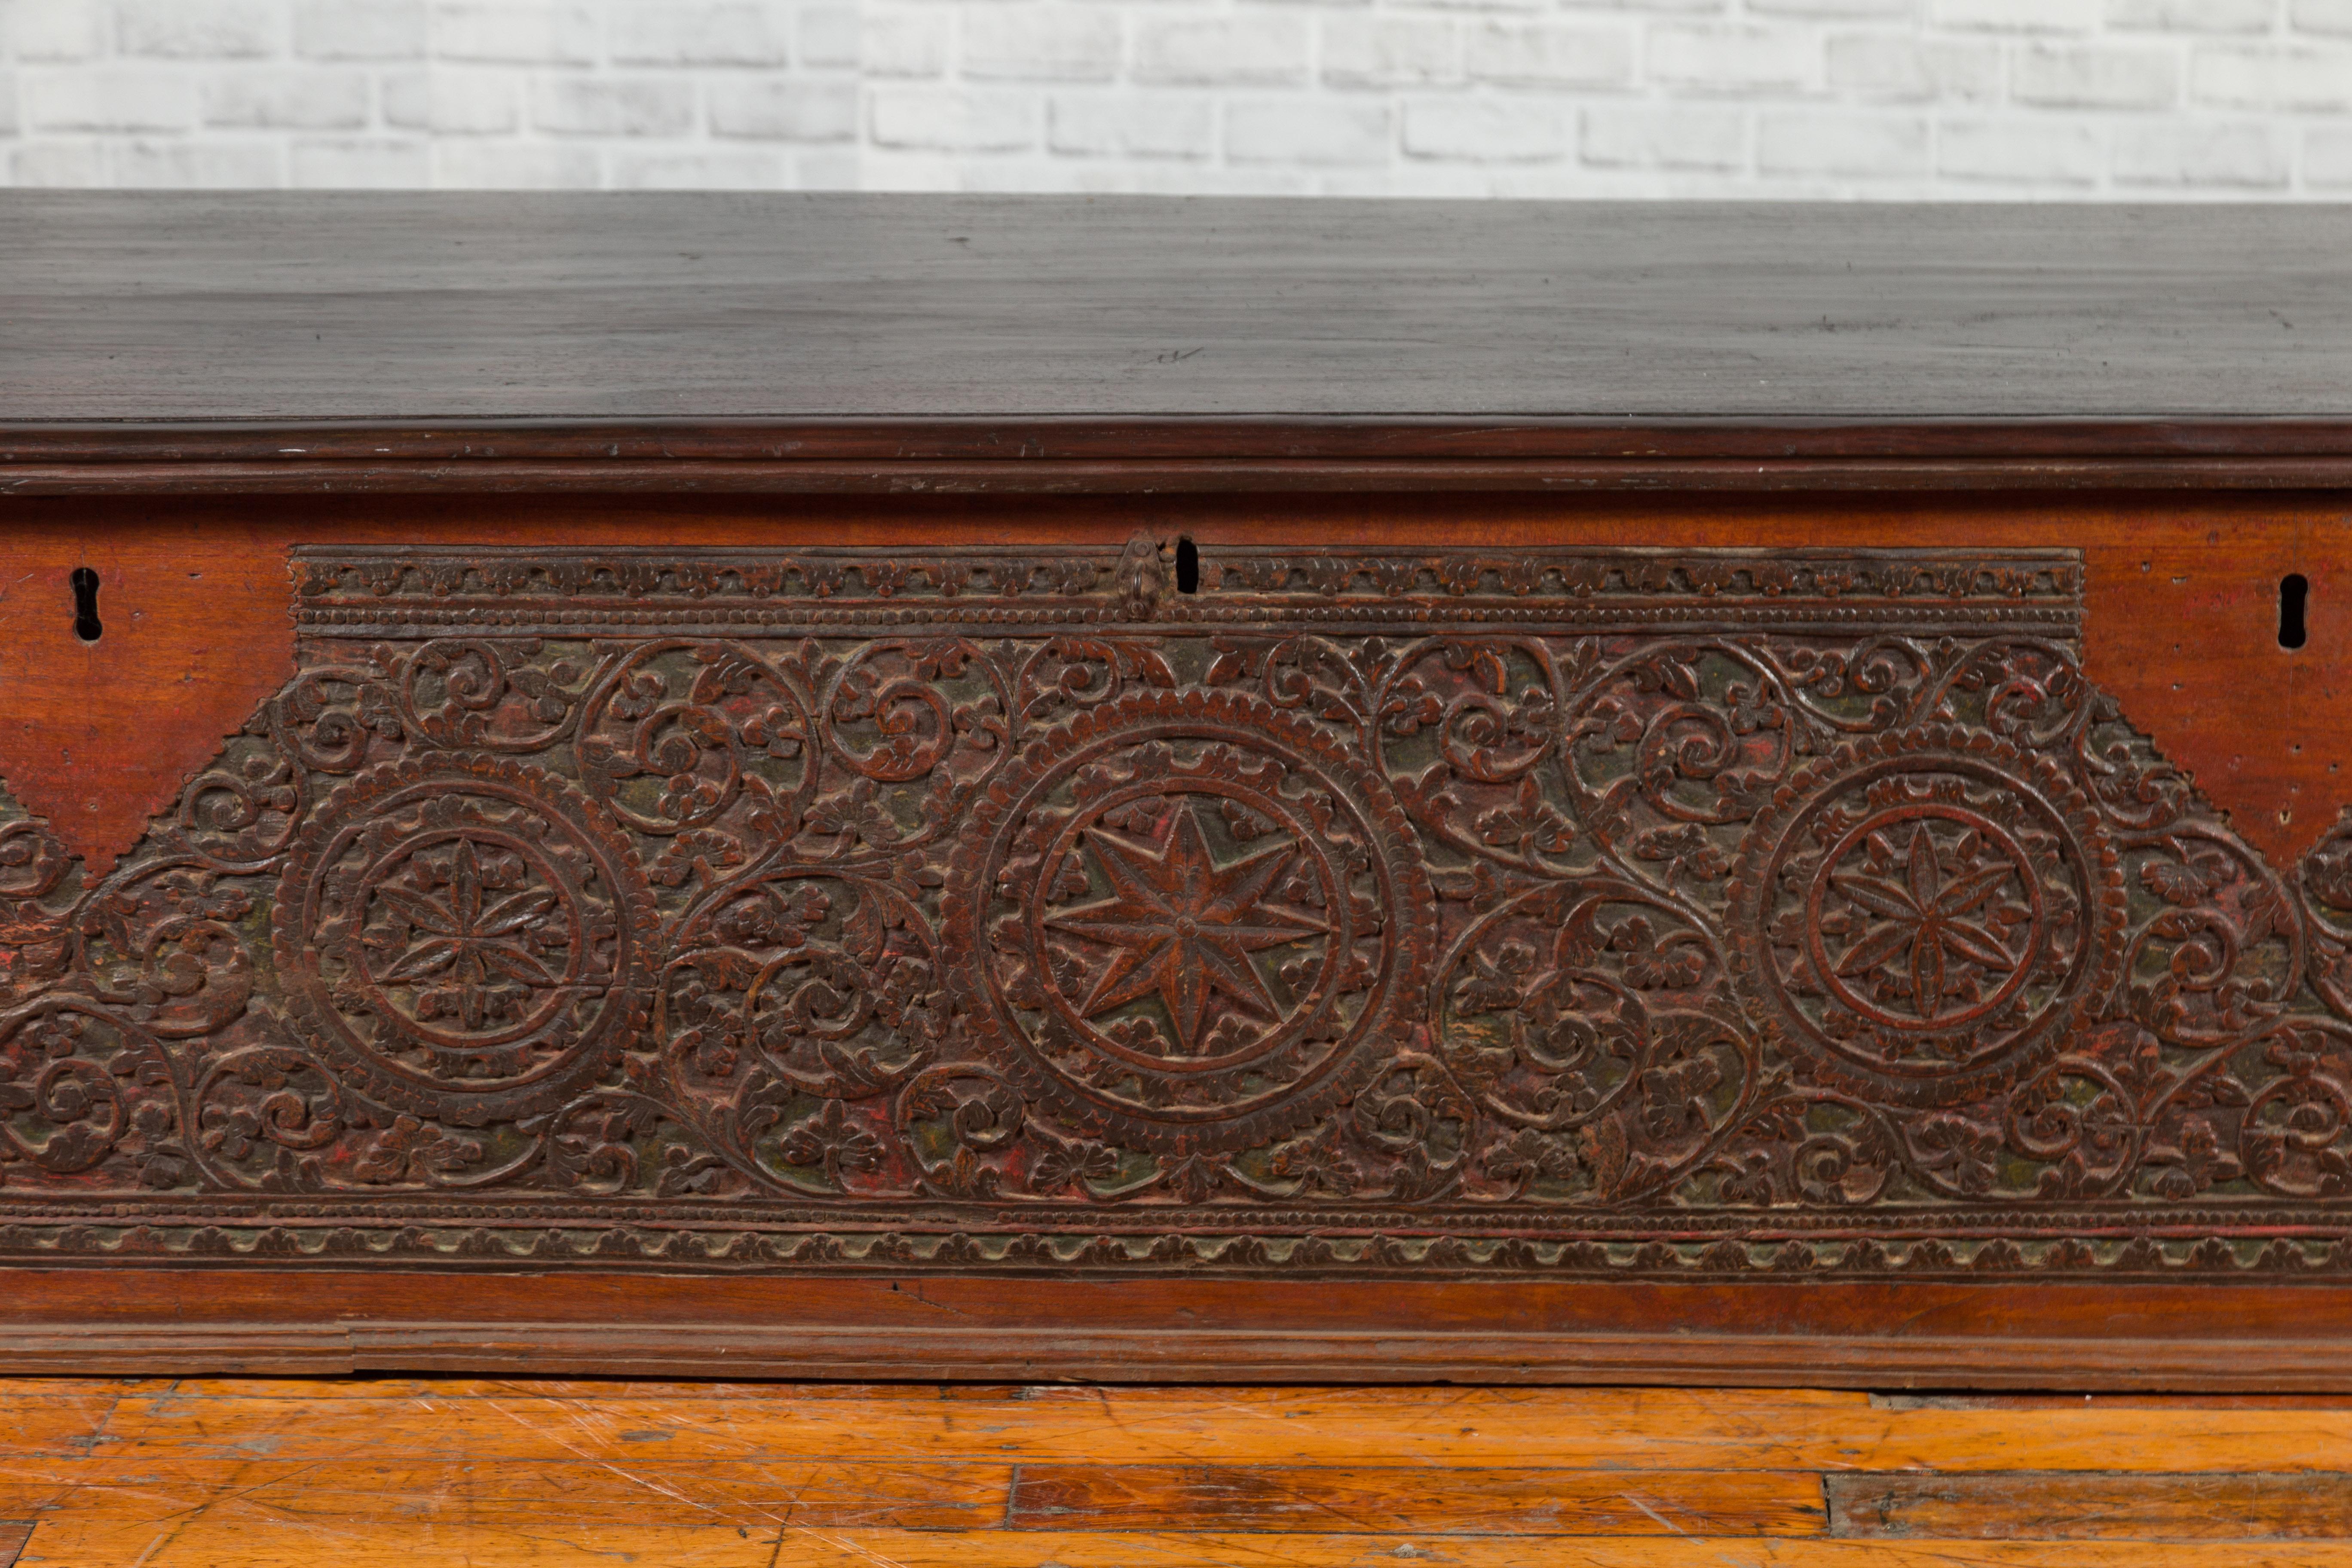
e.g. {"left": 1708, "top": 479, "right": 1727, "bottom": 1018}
{"left": 0, "top": 1267, "right": 2352, "bottom": 1391}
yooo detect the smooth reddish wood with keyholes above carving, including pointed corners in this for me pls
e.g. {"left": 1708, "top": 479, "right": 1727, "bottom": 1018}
{"left": 0, "top": 491, "right": 2352, "bottom": 865}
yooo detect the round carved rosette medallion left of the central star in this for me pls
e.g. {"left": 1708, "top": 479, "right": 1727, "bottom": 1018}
{"left": 275, "top": 755, "right": 654, "bottom": 1126}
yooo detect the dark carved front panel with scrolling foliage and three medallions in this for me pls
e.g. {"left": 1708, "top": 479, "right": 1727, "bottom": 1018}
{"left": 0, "top": 538, "right": 2352, "bottom": 1277}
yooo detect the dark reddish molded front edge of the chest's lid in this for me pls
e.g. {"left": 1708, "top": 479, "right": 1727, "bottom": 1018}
{"left": 0, "top": 419, "right": 2352, "bottom": 496}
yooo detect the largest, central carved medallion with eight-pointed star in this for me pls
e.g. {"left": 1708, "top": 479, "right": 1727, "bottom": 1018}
{"left": 948, "top": 691, "right": 1435, "bottom": 1152}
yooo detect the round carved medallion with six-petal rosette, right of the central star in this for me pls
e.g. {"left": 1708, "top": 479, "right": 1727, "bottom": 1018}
{"left": 1729, "top": 726, "right": 2124, "bottom": 1105}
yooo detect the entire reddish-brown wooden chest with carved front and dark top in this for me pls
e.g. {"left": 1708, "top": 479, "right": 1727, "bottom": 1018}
{"left": 0, "top": 195, "right": 2352, "bottom": 1387}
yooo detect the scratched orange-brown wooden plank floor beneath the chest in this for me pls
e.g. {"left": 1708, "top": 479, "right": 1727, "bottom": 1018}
{"left": 0, "top": 1378, "right": 2352, "bottom": 1568}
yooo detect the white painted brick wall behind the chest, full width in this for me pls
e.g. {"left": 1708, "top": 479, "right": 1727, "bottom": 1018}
{"left": 14, "top": 0, "right": 2352, "bottom": 200}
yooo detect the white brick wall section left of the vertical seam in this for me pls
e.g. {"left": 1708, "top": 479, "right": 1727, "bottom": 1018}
{"left": 0, "top": 0, "right": 861, "bottom": 188}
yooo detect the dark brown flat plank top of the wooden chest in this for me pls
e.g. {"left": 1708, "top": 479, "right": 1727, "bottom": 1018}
{"left": 14, "top": 193, "right": 2352, "bottom": 432}
